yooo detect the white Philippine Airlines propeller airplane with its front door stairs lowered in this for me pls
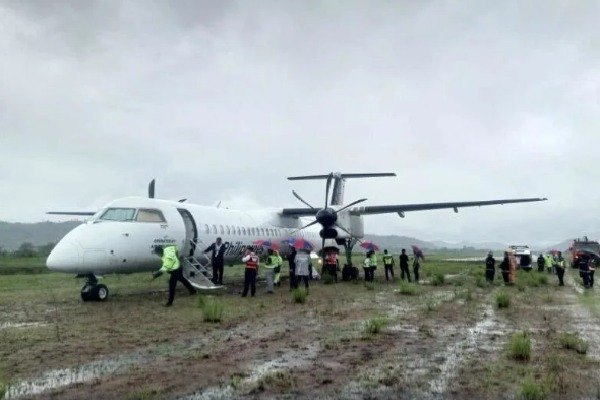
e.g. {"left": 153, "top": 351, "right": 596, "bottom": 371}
{"left": 46, "top": 172, "right": 547, "bottom": 301}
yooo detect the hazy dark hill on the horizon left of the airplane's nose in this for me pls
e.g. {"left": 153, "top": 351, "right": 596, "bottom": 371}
{"left": 0, "top": 221, "right": 82, "bottom": 250}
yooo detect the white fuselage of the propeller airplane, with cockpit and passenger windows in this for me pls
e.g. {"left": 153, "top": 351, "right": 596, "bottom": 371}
{"left": 46, "top": 197, "right": 321, "bottom": 275}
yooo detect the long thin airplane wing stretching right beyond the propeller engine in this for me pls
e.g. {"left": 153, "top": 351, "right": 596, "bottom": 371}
{"left": 350, "top": 197, "right": 548, "bottom": 217}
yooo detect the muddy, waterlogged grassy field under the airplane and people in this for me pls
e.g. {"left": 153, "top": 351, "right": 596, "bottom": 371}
{"left": 0, "top": 257, "right": 600, "bottom": 399}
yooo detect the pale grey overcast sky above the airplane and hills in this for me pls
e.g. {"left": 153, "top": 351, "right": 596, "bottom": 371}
{"left": 0, "top": 0, "right": 600, "bottom": 243}
